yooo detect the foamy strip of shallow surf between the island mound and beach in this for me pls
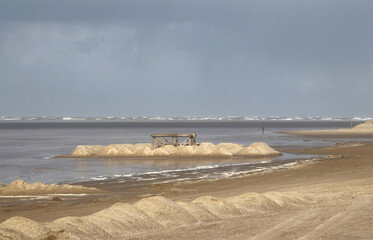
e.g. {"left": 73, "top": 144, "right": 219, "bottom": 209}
{"left": 52, "top": 150, "right": 316, "bottom": 186}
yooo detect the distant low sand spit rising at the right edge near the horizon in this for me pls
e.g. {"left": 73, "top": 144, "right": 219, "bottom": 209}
{"left": 283, "top": 121, "right": 373, "bottom": 137}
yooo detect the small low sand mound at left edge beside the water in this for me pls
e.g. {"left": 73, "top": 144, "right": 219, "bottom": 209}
{"left": 0, "top": 180, "right": 99, "bottom": 195}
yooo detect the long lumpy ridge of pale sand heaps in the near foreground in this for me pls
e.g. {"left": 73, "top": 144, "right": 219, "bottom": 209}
{"left": 0, "top": 192, "right": 312, "bottom": 239}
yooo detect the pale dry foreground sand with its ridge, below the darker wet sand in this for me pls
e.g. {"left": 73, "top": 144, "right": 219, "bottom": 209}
{"left": 0, "top": 181, "right": 373, "bottom": 240}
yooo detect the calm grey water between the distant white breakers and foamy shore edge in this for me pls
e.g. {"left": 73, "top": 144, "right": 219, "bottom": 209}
{"left": 0, "top": 120, "right": 366, "bottom": 184}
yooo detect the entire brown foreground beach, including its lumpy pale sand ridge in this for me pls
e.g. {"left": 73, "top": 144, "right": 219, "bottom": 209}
{"left": 0, "top": 143, "right": 373, "bottom": 239}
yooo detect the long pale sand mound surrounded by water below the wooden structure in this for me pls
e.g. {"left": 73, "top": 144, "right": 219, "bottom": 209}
{"left": 70, "top": 142, "right": 281, "bottom": 158}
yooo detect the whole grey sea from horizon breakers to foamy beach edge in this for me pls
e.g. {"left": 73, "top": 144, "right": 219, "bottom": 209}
{"left": 0, "top": 116, "right": 371, "bottom": 184}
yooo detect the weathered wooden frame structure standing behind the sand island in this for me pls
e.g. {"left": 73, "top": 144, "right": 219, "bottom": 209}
{"left": 151, "top": 133, "right": 197, "bottom": 148}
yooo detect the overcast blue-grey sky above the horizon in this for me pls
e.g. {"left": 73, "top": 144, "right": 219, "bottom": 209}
{"left": 0, "top": 0, "right": 373, "bottom": 117}
